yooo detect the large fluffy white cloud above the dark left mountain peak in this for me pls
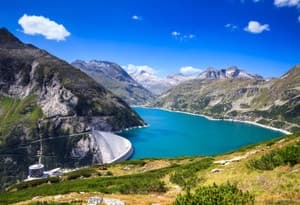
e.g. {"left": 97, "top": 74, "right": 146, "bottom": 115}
{"left": 18, "top": 14, "right": 71, "bottom": 41}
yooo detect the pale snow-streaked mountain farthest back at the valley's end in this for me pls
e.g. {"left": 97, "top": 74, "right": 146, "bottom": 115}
{"left": 128, "top": 68, "right": 194, "bottom": 95}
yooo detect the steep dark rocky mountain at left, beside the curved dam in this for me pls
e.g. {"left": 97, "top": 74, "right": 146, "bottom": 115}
{"left": 0, "top": 28, "right": 144, "bottom": 187}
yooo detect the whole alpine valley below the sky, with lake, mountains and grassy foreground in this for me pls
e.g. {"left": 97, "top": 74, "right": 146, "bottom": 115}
{"left": 0, "top": 23, "right": 300, "bottom": 205}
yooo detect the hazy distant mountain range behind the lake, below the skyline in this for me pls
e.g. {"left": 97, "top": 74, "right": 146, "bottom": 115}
{"left": 72, "top": 60, "right": 263, "bottom": 97}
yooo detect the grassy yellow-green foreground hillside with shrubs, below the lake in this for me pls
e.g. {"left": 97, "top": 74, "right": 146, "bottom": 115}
{"left": 0, "top": 134, "right": 300, "bottom": 205}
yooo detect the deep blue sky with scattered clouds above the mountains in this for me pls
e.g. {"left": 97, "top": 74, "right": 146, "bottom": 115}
{"left": 0, "top": 0, "right": 300, "bottom": 77}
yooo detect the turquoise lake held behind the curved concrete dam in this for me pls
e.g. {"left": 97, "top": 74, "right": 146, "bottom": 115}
{"left": 120, "top": 107, "right": 284, "bottom": 159}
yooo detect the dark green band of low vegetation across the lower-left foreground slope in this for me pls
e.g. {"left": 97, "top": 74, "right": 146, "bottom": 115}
{"left": 0, "top": 158, "right": 213, "bottom": 204}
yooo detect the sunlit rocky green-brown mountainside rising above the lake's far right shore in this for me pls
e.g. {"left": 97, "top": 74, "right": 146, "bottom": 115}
{"left": 150, "top": 65, "right": 300, "bottom": 132}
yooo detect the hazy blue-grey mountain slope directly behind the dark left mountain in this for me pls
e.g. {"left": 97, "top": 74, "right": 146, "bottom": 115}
{"left": 71, "top": 60, "right": 154, "bottom": 105}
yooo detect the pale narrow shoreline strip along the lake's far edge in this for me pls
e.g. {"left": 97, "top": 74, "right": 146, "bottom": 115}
{"left": 132, "top": 106, "right": 293, "bottom": 135}
